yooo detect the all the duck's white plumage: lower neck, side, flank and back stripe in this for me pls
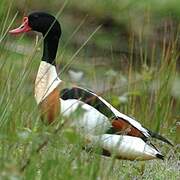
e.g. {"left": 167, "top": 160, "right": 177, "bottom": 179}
{"left": 35, "top": 61, "right": 163, "bottom": 160}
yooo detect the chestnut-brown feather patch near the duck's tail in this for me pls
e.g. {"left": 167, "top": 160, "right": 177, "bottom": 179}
{"left": 112, "top": 118, "right": 144, "bottom": 137}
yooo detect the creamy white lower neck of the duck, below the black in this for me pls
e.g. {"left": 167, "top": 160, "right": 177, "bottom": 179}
{"left": 35, "top": 61, "right": 61, "bottom": 104}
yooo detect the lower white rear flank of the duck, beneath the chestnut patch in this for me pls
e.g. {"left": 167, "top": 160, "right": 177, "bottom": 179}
{"left": 86, "top": 134, "right": 160, "bottom": 160}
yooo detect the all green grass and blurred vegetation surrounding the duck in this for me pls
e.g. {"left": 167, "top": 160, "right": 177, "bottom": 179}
{"left": 0, "top": 0, "right": 180, "bottom": 179}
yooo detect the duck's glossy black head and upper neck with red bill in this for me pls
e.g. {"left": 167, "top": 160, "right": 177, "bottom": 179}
{"left": 9, "top": 12, "right": 61, "bottom": 64}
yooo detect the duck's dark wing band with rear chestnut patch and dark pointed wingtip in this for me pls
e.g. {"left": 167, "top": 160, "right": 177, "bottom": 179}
{"left": 60, "top": 87, "right": 172, "bottom": 145}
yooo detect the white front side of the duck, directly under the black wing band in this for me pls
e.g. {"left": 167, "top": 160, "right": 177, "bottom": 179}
{"left": 60, "top": 99, "right": 111, "bottom": 135}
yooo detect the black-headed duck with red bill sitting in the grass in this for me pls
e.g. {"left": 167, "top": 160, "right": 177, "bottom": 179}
{"left": 9, "top": 12, "right": 173, "bottom": 160}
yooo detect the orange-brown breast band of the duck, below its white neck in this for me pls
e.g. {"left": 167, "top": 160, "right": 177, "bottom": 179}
{"left": 39, "top": 88, "right": 60, "bottom": 124}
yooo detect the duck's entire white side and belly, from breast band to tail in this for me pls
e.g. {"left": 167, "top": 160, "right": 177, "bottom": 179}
{"left": 61, "top": 100, "right": 159, "bottom": 160}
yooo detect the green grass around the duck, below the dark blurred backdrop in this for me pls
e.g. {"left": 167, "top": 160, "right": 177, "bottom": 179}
{"left": 0, "top": 1, "right": 180, "bottom": 179}
